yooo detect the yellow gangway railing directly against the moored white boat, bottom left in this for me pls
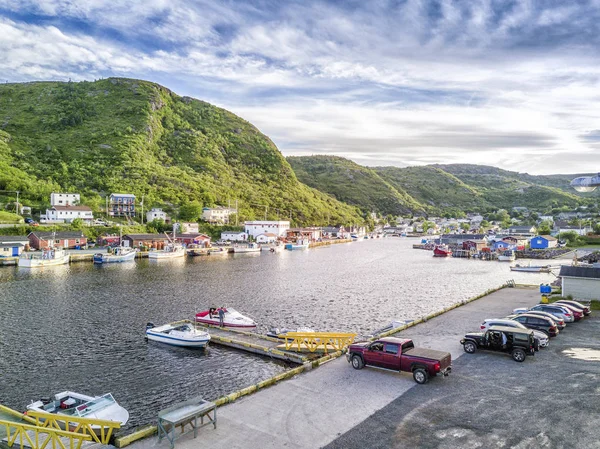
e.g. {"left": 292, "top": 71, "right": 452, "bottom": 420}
{"left": 27, "top": 410, "right": 121, "bottom": 444}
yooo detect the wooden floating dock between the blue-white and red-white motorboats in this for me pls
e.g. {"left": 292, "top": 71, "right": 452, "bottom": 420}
{"left": 206, "top": 326, "right": 322, "bottom": 364}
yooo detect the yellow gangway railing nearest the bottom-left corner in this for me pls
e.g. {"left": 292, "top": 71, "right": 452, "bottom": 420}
{"left": 0, "top": 420, "right": 92, "bottom": 449}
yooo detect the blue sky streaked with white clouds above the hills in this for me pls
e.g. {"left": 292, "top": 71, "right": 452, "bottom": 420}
{"left": 0, "top": 0, "right": 600, "bottom": 174}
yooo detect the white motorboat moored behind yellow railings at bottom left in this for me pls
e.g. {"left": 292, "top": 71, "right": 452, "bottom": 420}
{"left": 27, "top": 391, "right": 129, "bottom": 432}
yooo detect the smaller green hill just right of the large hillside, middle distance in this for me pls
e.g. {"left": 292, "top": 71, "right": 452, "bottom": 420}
{"left": 287, "top": 156, "right": 424, "bottom": 215}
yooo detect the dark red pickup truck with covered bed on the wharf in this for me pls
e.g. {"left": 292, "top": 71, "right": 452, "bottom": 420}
{"left": 346, "top": 337, "right": 452, "bottom": 384}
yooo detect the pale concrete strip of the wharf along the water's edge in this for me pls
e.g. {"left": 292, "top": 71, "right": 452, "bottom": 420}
{"left": 132, "top": 288, "right": 600, "bottom": 449}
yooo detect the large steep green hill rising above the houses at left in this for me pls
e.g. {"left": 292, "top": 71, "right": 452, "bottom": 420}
{"left": 0, "top": 78, "right": 362, "bottom": 224}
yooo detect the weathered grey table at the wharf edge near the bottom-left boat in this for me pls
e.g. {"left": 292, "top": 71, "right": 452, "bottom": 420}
{"left": 158, "top": 397, "right": 217, "bottom": 449}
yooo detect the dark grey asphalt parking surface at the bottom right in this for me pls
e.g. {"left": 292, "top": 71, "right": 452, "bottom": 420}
{"left": 326, "top": 289, "right": 600, "bottom": 449}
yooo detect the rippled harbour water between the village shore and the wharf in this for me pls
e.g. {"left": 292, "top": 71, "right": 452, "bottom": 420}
{"left": 0, "top": 238, "right": 554, "bottom": 427}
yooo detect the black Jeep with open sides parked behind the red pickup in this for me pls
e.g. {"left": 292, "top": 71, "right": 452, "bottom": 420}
{"left": 460, "top": 326, "right": 535, "bottom": 362}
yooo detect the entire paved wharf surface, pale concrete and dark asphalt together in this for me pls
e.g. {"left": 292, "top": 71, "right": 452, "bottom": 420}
{"left": 132, "top": 289, "right": 600, "bottom": 449}
